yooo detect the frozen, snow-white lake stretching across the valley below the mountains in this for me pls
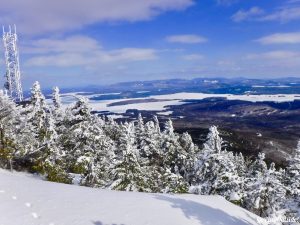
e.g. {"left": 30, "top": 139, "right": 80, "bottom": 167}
{"left": 58, "top": 92, "right": 300, "bottom": 113}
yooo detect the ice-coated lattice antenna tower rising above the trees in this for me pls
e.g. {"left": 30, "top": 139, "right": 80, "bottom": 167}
{"left": 3, "top": 25, "right": 23, "bottom": 101}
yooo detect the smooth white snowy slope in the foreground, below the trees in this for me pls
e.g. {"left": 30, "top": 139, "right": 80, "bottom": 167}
{"left": 0, "top": 170, "right": 257, "bottom": 225}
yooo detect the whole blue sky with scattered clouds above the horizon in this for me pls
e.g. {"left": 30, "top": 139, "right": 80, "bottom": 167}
{"left": 0, "top": 0, "right": 300, "bottom": 89}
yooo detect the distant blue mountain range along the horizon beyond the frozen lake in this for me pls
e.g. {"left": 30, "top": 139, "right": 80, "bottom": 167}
{"left": 62, "top": 77, "right": 300, "bottom": 97}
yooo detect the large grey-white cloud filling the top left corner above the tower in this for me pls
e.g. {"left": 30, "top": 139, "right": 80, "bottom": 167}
{"left": 0, "top": 0, "right": 194, "bottom": 34}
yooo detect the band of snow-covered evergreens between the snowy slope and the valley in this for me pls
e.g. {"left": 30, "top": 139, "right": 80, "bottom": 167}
{"left": 0, "top": 82, "right": 300, "bottom": 221}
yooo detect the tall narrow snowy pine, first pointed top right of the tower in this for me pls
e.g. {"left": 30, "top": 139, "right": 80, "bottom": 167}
{"left": 25, "top": 82, "right": 70, "bottom": 183}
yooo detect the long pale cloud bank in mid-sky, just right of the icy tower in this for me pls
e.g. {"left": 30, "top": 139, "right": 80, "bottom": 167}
{"left": 22, "top": 36, "right": 157, "bottom": 67}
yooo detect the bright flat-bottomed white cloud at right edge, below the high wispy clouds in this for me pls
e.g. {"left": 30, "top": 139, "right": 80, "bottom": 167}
{"left": 256, "top": 32, "right": 300, "bottom": 45}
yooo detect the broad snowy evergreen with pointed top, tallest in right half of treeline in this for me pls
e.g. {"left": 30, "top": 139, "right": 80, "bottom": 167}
{"left": 190, "top": 126, "right": 244, "bottom": 203}
